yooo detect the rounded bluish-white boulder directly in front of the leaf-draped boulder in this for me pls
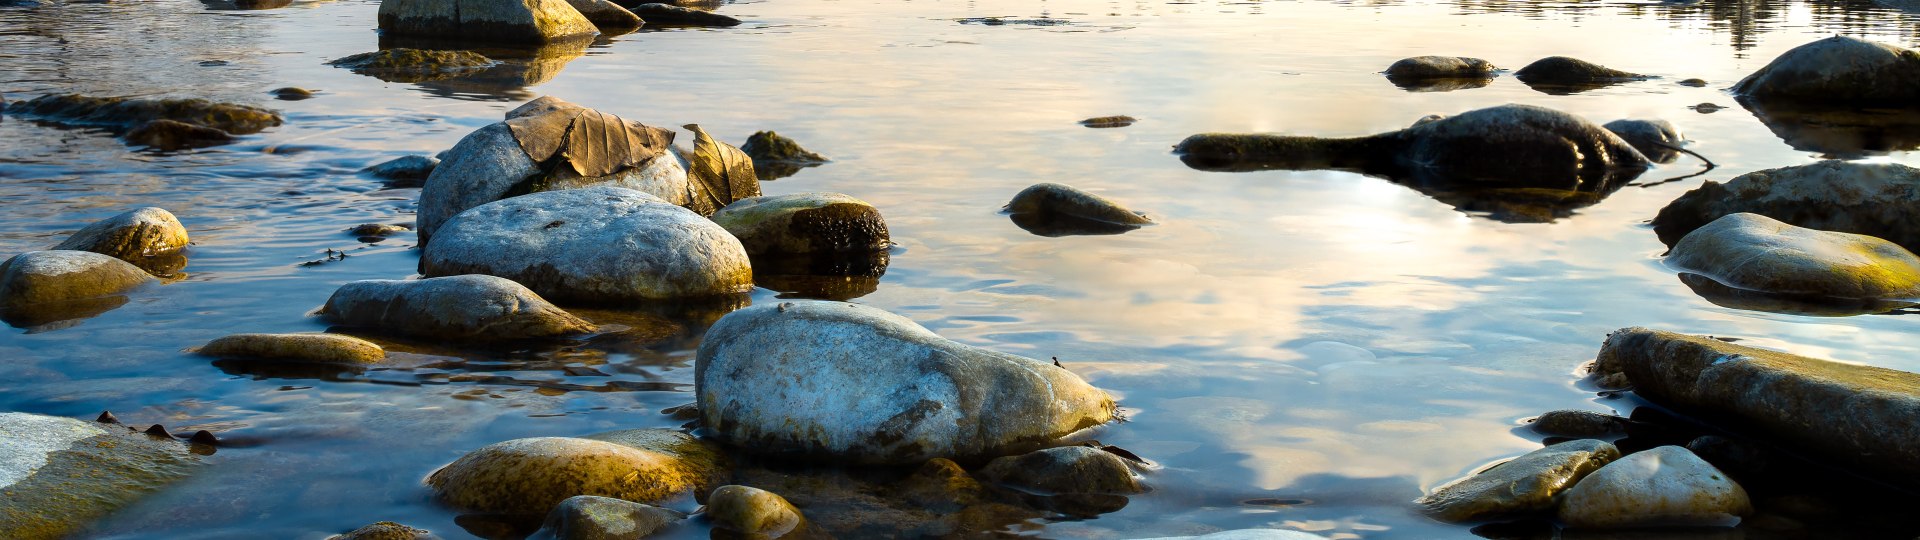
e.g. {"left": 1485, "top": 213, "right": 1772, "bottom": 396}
{"left": 420, "top": 186, "right": 753, "bottom": 304}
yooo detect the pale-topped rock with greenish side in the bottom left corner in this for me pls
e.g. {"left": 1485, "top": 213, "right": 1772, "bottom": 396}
{"left": 0, "top": 413, "right": 200, "bottom": 540}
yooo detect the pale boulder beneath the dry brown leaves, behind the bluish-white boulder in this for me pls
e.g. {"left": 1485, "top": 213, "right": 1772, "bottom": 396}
{"left": 415, "top": 98, "right": 699, "bottom": 244}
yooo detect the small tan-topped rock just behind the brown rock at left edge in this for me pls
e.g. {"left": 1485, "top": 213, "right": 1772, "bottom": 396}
{"left": 54, "top": 206, "right": 190, "bottom": 275}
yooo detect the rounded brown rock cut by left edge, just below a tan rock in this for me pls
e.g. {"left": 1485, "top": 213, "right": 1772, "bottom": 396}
{"left": 0, "top": 250, "right": 156, "bottom": 327}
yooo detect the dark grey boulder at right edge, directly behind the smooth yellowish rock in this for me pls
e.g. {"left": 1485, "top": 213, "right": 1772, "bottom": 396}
{"left": 1653, "top": 160, "right": 1920, "bottom": 250}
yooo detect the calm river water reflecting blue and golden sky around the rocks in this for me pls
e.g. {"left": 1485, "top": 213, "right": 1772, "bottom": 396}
{"left": 0, "top": 0, "right": 1920, "bottom": 538}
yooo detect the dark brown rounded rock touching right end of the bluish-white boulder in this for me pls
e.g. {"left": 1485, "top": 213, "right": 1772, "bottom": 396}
{"left": 712, "top": 192, "right": 893, "bottom": 256}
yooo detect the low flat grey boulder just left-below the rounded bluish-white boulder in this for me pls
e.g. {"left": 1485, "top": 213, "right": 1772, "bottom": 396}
{"left": 321, "top": 275, "right": 595, "bottom": 340}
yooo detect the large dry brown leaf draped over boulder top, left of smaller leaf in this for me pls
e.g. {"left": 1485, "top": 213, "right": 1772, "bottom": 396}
{"left": 507, "top": 108, "right": 674, "bottom": 179}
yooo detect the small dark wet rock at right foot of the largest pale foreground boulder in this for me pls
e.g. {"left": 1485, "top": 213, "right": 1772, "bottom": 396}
{"left": 979, "top": 446, "right": 1146, "bottom": 496}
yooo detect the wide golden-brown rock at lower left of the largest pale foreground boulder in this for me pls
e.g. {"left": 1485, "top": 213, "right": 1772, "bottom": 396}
{"left": 426, "top": 430, "right": 726, "bottom": 515}
